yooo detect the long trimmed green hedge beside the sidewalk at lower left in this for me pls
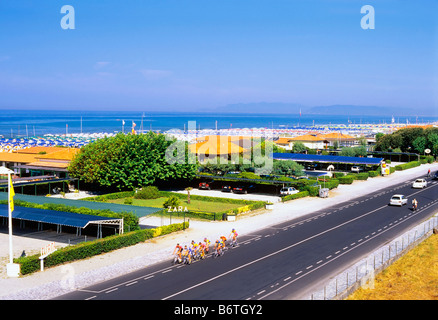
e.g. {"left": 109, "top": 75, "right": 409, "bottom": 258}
{"left": 14, "top": 222, "right": 189, "bottom": 275}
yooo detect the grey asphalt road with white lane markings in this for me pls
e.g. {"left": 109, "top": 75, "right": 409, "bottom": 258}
{"left": 58, "top": 172, "right": 438, "bottom": 300}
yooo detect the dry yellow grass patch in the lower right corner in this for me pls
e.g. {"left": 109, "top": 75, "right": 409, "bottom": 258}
{"left": 347, "top": 235, "right": 438, "bottom": 300}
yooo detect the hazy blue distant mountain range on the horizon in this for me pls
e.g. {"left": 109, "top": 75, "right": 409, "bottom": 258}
{"left": 217, "top": 102, "right": 418, "bottom": 116}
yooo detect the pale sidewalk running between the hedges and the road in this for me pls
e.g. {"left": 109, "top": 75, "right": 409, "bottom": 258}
{"left": 0, "top": 164, "right": 438, "bottom": 300}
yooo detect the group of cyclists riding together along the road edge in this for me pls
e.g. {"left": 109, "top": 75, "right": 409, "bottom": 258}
{"left": 173, "top": 229, "right": 237, "bottom": 264}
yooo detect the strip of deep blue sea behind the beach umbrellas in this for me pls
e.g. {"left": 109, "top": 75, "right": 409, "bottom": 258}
{"left": 0, "top": 110, "right": 438, "bottom": 138}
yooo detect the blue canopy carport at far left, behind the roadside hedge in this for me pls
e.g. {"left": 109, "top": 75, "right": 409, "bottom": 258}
{"left": 0, "top": 205, "right": 123, "bottom": 238}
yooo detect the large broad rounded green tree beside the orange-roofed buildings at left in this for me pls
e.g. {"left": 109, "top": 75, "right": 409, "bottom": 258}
{"left": 68, "top": 132, "right": 197, "bottom": 190}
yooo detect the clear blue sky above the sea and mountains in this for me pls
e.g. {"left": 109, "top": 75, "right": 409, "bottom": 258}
{"left": 0, "top": 0, "right": 438, "bottom": 112}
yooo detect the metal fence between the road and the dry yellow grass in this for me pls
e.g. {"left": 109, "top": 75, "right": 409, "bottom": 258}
{"left": 307, "top": 214, "right": 438, "bottom": 300}
